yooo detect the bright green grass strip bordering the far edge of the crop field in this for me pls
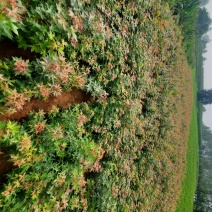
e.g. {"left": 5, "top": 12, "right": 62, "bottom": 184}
{"left": 176, "top": 71, "right": 198, "bottom": 212}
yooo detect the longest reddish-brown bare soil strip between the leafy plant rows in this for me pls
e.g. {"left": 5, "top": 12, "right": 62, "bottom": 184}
{"left": 0, "top": 88, "right": 94, "bottom": 121}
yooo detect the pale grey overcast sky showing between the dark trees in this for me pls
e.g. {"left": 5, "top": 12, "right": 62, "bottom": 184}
{"left": 203, "top": 0, "right": 212, "bottom": 129}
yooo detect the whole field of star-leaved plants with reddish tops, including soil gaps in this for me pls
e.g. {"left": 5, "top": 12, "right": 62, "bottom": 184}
{"left": 0, "top": 0, "right": 193, "bottom": 212}
